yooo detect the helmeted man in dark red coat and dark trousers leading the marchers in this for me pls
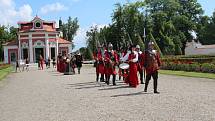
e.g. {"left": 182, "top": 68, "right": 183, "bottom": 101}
{"left": 143, "top": 42, "right": 161, "bottom": 94}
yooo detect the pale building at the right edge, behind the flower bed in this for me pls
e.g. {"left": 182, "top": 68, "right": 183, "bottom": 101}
{"left": 185, "top": 41, "right": 215, "bottom": 55}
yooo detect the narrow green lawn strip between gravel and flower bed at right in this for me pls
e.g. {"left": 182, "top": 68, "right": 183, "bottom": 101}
{"left": 159, "top": 70, "right": 215, "bottom": 79}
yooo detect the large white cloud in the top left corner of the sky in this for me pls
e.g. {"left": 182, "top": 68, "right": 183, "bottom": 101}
{"left": 0, "top": 0, "right": 32, "bottom": 25}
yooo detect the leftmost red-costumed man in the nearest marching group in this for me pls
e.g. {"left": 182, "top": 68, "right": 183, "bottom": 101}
{"left": 94, "top": 45, "right": 104, "bottom": 82}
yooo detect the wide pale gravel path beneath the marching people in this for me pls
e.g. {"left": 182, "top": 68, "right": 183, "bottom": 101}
{"left": 0, "top": 66, "right": 215, "bottom": 121}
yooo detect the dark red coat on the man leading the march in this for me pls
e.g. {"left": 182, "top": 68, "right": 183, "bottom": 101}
{"left": 143, "top": 51, "right": 161, "bottom": 74}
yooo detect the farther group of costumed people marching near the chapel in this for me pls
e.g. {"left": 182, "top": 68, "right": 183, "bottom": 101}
{"left": 57, "top": 52, "right": 83, "bottom": 74}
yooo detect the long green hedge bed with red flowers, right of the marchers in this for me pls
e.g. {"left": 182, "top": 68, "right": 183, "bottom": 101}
{"left": 161, "top": 55, "right": 215, "bottom": 73}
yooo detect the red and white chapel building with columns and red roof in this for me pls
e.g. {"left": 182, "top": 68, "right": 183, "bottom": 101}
{"left": 4, "top": 16, "right": 72, "bottom": 63}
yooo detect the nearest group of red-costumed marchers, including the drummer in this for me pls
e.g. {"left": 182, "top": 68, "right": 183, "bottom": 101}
{"left": 94, "top": 42, "right": 161, "bottom": 93}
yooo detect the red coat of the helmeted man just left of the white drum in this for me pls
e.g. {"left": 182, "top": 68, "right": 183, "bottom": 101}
{"left": 104, "top": 50, "right": 118, "bottom": 75}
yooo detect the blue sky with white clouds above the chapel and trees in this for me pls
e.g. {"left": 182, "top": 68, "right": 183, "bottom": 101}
{"left": 0, "top": 0, "right": 215, "bottom": 49}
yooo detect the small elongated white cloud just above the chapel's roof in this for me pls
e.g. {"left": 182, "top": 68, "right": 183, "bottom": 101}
{"left": 40, "top": 2, "right": 67, "bottom": 14}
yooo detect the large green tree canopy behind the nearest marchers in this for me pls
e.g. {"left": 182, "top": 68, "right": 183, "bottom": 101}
{"left": 87, "top": 0, "right": 215, "bottom": 55}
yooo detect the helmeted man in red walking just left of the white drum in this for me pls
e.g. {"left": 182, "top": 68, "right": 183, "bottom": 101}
{"left": 105, "top": 44, "right": 118, "bottom": 85}
